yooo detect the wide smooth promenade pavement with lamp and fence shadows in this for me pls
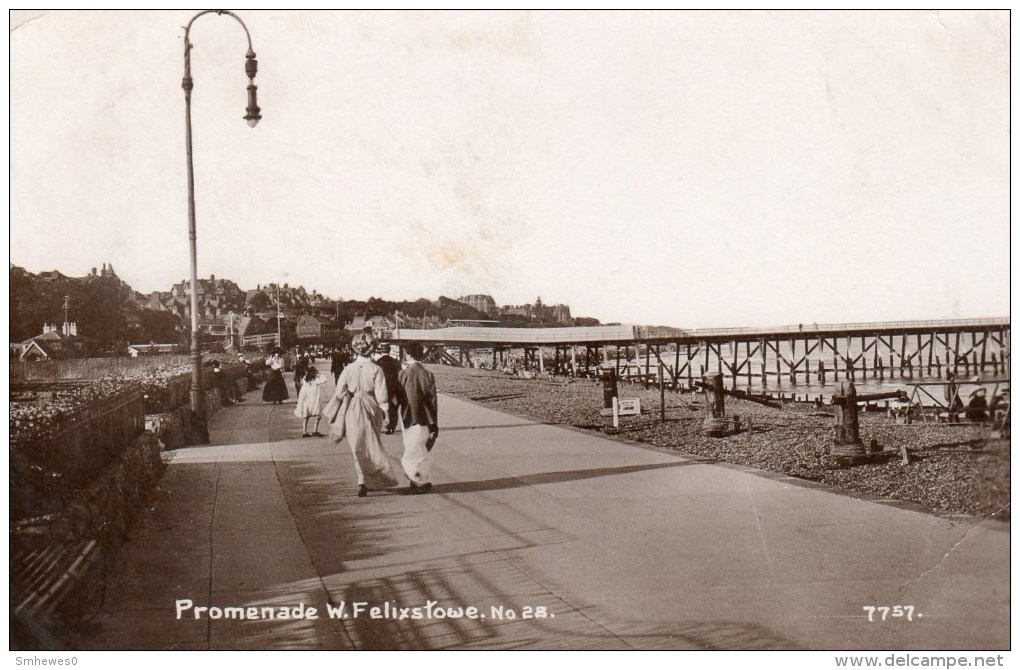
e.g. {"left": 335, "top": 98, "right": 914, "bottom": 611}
{"left": 72, "top": 371, "right": 1010, "bottom": 650}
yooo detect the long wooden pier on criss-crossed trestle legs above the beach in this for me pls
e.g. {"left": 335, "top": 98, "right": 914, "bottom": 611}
{"left": 391, "top": 317, "right": 1010, "bottom": 389}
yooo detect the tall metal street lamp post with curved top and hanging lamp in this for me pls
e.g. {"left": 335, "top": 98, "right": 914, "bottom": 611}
{"left": 181, "top": 9, "right": 262, "bottom": 423}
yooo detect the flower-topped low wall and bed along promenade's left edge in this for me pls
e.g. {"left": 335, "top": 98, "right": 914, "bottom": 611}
{"left": 9, "top": 365, "right": 248, "bottom": 629}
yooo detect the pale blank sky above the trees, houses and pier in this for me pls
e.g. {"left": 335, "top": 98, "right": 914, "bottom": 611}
{"left": 10, "top": 10, "right": 1010, "bottom": 327}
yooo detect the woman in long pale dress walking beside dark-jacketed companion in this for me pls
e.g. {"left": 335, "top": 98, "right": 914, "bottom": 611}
{"left": 335, "top": 332, "right": 397, "bottom": 498}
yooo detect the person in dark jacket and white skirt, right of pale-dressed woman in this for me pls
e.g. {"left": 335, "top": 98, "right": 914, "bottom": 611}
{"left": 397, "top": 342, "right": 440, "bottom": 494}
